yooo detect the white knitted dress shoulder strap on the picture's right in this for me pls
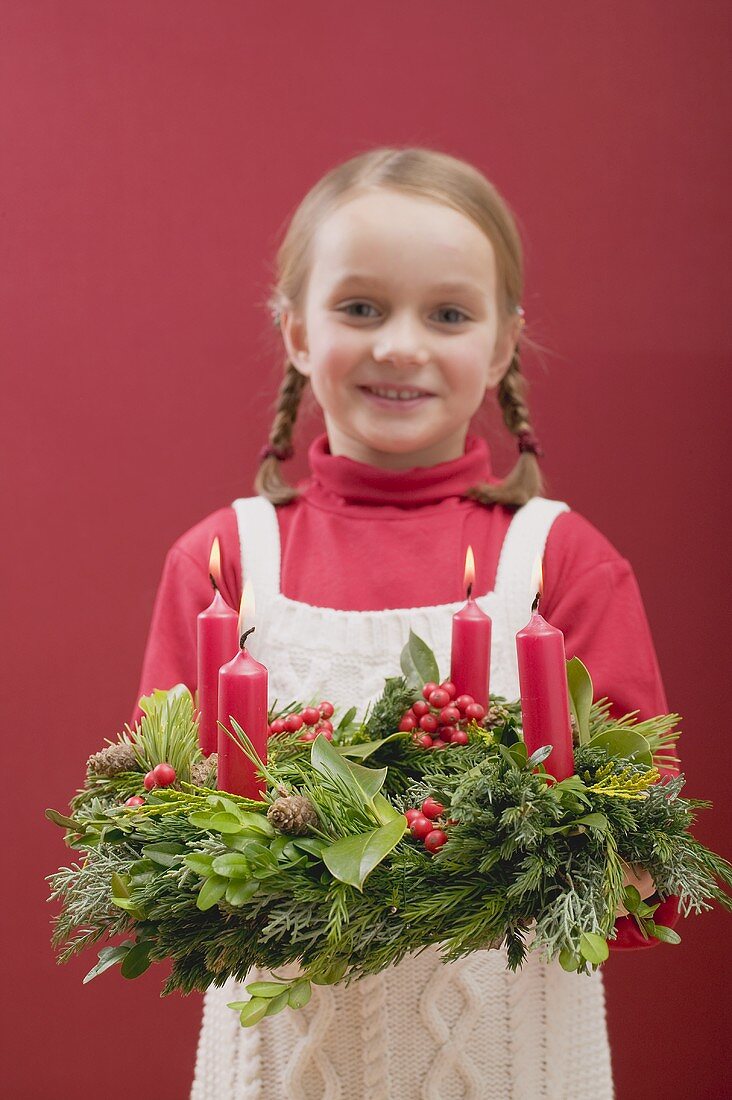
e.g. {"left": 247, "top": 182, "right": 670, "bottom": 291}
{"left": 495, "top": 496, "right": 570, "bottom": 633}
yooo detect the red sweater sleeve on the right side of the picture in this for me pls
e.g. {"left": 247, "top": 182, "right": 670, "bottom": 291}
{"left": 539, "top": 512, "right": 679, "bottom": 950}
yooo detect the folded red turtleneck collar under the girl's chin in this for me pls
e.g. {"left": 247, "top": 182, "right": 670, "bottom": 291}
{"left": 306, "top": 433, "right": 496, "bottom": 508}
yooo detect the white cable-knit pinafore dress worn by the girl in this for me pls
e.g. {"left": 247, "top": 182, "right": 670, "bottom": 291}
{"left": 190, "top": 497, "right": 613, "bottom": 1100}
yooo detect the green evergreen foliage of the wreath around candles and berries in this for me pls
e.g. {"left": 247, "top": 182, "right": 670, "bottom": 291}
{"left": 47, "top": 635, "right": 732, "bottom": 1026}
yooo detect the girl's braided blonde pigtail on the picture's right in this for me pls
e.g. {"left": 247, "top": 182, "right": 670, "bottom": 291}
{"left": 466, "top": 347, "right": 545, "bottom": 506}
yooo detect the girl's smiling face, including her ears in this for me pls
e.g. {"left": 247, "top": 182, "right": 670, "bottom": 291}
{"left": 281, "top": 189, "right": 520, "bottom": 470}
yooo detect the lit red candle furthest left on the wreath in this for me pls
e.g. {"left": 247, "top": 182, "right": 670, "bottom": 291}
{"left": 197, "top": 536, "right": 239, "bottom": 756}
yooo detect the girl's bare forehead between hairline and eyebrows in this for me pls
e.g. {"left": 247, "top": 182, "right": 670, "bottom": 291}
{"left": 310, "top": 190, "right": 495, "bottom": 293}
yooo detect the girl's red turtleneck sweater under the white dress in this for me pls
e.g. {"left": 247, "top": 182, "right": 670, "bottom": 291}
{"left": 132, "top": 435, "right": 676, "bottom": 947}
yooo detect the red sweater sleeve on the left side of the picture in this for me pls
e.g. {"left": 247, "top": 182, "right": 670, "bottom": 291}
{"left": 131, "top": 508, "right": 241, "bottom": 724}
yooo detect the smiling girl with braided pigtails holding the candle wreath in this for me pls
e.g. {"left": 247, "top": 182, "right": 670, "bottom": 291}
{"left": 133, "top": 149, "right": 675, "bottom": 1100}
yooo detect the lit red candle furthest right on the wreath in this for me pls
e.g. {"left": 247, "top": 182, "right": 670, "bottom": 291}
{"left": 516, "top": 562, "right": 575, "bottom": 780}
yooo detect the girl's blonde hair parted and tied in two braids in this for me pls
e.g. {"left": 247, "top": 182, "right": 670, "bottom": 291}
{"left": 254, "top": 147, "right": 544, "bottom": 505}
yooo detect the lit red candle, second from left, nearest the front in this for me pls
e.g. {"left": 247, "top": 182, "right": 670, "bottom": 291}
{"left": 217, "top": 581, "right": 269, "bottom": 799}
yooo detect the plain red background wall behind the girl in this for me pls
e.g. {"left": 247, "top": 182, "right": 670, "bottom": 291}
{"left": 0, "top": 0, "right": 732, "bottom": 1100}
